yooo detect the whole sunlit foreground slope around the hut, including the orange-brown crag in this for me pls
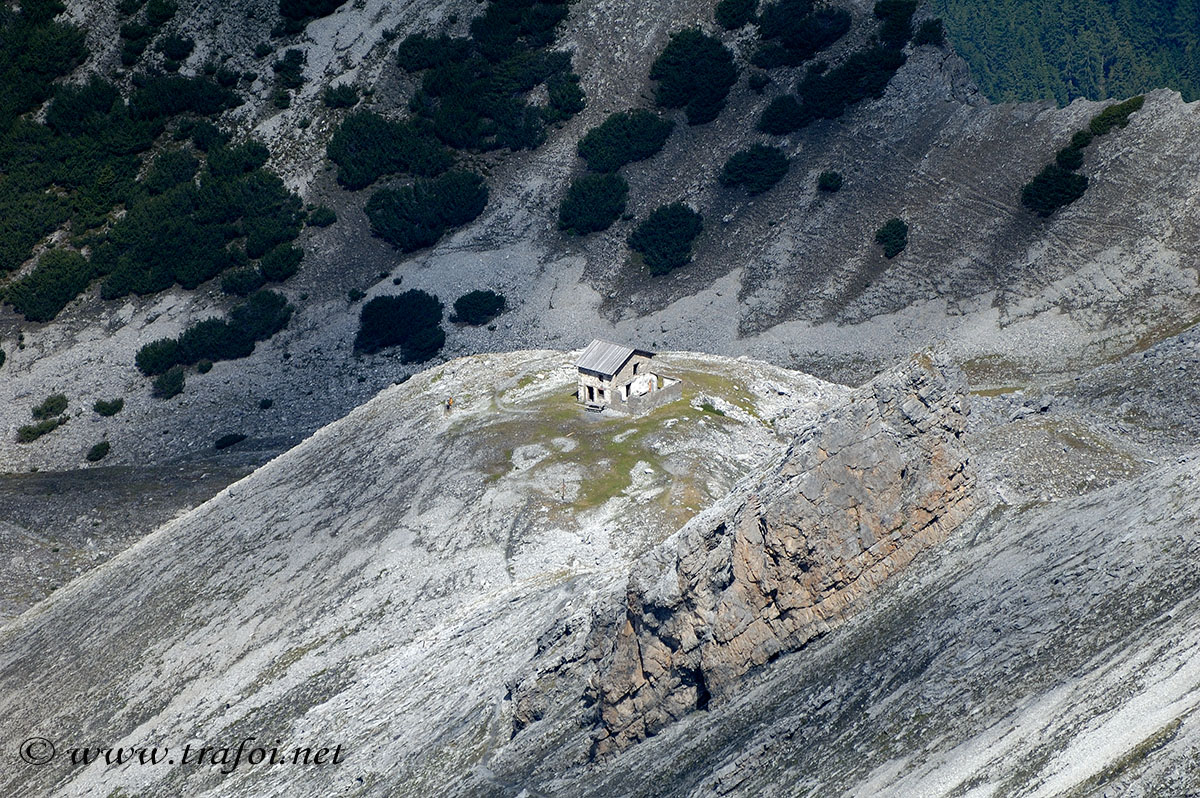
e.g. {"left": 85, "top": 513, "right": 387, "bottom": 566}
{"left": 0, "top": 343, "right": 1200, "bottom": 797}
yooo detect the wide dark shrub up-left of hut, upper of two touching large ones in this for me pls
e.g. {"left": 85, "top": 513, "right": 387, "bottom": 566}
{"left": 325, "top": 112, "right": 454, "bottom": 191}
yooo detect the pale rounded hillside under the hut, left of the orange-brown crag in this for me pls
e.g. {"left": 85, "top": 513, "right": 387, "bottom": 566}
{"left": 0, "top": 352, "right": 845, "bottom": 796}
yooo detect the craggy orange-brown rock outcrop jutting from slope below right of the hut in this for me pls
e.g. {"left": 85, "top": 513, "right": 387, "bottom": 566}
{"left": 514, "top": 356, "right": 973, "bottom": 756}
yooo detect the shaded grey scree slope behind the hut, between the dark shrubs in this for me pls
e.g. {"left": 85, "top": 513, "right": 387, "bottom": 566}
{"left": 0, "top": 0, "right": 1200, "bottom": 469}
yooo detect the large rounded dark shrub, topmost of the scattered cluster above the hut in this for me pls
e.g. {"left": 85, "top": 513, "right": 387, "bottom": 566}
{"left": 650, "top": 28, "right": 738, "bottom": 125}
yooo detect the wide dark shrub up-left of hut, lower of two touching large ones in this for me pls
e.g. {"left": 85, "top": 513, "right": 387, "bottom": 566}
{"left": 366, "top": 172, "right": 487, "bottom": 252}
